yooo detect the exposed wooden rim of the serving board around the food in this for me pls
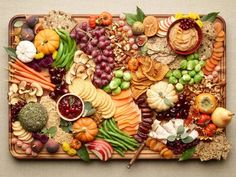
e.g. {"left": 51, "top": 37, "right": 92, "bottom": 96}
{"left": 8, "top": 14, "right": 226, "bottom": 160}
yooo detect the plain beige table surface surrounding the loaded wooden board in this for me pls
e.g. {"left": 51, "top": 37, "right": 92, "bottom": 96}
{"left": 0, "top": 0, "right": 236, "bottom": 177}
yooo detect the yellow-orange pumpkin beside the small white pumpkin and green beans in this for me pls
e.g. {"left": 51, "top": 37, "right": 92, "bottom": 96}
{"left": 34, "top": 29, "right": 60, "bottom": 55}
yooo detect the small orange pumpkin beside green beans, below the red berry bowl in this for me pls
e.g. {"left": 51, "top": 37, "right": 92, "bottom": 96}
{"left": 72, "top": 117, "right": 98, "bottom": 142}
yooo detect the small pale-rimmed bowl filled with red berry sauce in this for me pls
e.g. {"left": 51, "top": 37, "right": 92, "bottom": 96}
{"left": 57, "top": 93, "right": 84, "bottom": 121}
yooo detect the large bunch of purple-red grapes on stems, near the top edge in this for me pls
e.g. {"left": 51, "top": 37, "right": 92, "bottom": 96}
{"left": 71, "top": 22, "right": 115, "bottom": 88}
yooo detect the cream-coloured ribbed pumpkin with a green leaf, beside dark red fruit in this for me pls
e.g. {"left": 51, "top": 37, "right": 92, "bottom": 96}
{"left": 147, "top": 81, "right": 178, "bottom": 112}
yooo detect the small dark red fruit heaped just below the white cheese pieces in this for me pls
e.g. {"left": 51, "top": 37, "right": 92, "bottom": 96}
{"left": 166, "top": 139, "right": 200, "bottom": 154}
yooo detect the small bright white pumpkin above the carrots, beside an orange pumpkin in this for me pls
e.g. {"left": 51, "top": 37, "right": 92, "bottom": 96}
{"left": 16, "top": 40, "right": 36, "bottom": 63}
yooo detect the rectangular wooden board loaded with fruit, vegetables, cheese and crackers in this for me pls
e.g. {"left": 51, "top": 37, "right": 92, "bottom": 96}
{"left": 8, "top": 11, "right": 229, "bottom": 161}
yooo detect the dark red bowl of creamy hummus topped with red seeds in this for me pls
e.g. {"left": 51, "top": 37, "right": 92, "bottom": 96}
{"left": 167, "top": 18, "right": 203, "bottom": 55}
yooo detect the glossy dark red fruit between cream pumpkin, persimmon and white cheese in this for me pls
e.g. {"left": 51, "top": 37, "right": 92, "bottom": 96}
{"left": 156, "top": 94, "right": 191, "bottom": 120}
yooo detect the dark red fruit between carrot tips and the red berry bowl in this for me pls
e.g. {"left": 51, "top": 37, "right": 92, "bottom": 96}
{"left": 49, "top": 68, "right": 68, "bottom": 99}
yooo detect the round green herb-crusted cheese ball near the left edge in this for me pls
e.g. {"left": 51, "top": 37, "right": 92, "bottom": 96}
{"left": 18, "top": 103, "right": 48, "bottom": 132}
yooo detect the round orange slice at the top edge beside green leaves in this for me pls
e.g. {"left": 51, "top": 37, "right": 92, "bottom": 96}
{"left": 143, "top": 16, "right": 159, "bottom": 37}
